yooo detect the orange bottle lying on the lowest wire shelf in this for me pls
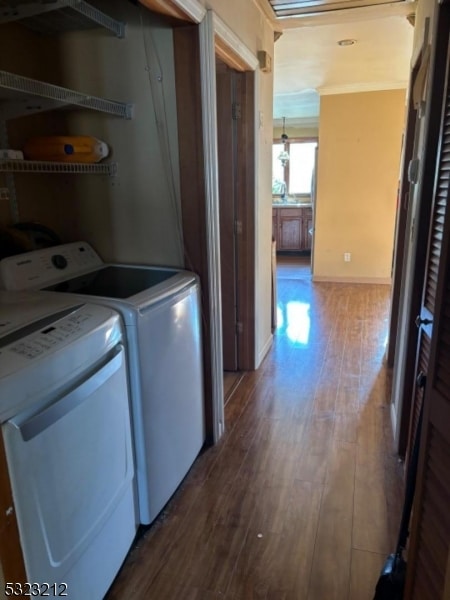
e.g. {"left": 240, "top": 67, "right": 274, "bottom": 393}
{"left": 23, "top": 135, "right": 109, "bottom": 163}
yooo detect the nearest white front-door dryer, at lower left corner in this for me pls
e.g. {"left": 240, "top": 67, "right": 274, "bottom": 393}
{"left": 0, "top": 292, "right": 138, "bottom": 600}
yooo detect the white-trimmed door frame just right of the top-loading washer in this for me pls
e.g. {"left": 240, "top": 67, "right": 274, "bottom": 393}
{"left": 200, "top": 10, "right": 259, "bottom": 443}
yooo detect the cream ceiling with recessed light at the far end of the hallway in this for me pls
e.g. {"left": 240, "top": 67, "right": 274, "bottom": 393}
{"left": 266, "top": 0, "right": 415, "bottom": 126}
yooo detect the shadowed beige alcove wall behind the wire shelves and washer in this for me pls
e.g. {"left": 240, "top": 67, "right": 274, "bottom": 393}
{"left": 52, "top": 0, "right": 183, "bottom": 266}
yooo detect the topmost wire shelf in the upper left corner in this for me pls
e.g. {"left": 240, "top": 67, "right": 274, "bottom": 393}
{"left": 0, "top": 0, "right": 125, "bottom": 38}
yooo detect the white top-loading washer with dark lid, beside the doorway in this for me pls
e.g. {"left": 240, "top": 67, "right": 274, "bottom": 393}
{"left": 0, "top": 242, "right": 205, "bottom": 524}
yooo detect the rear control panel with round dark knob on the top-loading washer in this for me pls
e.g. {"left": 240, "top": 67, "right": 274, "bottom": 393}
{"left": 0, "top": 242, "right": 103, "bottom": 290}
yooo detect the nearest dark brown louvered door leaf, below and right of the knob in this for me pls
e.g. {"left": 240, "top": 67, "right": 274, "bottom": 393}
{"left": 405, "top": 199, "right": 450, "bottom": 600}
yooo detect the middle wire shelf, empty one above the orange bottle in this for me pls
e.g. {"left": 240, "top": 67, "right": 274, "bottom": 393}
{"left": 0, "top": 71, "right": 133, "bottom": 119}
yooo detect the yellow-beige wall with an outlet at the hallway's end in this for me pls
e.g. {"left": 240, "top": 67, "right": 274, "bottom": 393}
{"left": 314, "top": 90, "right": 405, "bottom": 282}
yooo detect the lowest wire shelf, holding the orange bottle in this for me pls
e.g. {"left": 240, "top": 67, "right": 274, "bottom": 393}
{"left": 0, "top": 159, "right": 117, "bottom": 176}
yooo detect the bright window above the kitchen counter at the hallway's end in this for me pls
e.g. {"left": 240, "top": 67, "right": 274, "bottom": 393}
{"left": 272, "top": 140, "right": 317, "bottom": 196}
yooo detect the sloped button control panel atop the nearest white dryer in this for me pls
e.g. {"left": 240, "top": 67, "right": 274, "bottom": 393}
{"left": 0, "top": 302, "right": 123, "bottom": 423}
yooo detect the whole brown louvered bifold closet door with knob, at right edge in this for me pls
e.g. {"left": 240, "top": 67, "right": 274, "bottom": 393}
{"left": 405, "top": 39, "right": 450, "bottom": 600}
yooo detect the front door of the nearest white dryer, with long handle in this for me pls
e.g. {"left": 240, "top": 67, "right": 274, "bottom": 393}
{"left": 2, "top": 346, "right": 136, "bottom": 600}
